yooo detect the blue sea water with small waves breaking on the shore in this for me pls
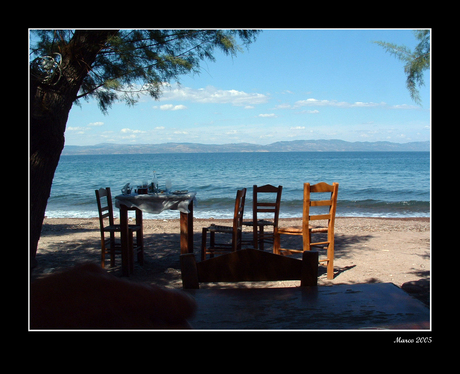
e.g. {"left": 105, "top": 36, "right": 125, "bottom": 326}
{"left": 46, "top": 152, "right": 430, "bottom": 219}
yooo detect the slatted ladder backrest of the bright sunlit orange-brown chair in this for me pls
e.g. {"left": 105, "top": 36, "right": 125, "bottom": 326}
{"left": 302, "top": 182, "right": 339, "bottom": 250}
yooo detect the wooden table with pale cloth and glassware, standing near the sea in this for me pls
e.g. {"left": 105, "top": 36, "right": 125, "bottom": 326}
{"left": 115, "top": 192, "right": 196, "bottom": 276}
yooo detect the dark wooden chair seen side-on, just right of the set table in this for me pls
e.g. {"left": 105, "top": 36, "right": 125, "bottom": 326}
{"left": 201, "top": 188, "right": 246, "bottom": 260}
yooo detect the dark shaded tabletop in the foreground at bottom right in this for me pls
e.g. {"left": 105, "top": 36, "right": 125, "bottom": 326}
{"left": 187, "top": 283, "right": 430, "bottom": 330}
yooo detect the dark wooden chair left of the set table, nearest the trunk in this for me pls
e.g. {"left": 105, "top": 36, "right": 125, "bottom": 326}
{"left": 95, "top": 187, "right": 144, "bottom": 268}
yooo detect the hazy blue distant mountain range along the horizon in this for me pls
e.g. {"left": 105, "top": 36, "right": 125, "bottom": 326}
{"left": 62, "top": 139, "right": 430, "bottom": 155}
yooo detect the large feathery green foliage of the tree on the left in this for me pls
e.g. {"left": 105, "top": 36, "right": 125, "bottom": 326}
{"left": 31, "top": 30, "right": 259, "bottom": 113}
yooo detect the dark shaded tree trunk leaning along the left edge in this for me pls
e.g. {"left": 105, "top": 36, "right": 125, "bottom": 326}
{"left": 30, "top": 30, "right": 118, "bottom": 267}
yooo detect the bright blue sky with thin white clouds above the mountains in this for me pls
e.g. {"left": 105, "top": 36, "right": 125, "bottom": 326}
{"left": 65, "top": 30, "right": 431, "bottom": 145}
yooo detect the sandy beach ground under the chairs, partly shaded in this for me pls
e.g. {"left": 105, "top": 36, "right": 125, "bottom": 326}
{"left": 31, "top": 217, "right": 431, "bottom": 305}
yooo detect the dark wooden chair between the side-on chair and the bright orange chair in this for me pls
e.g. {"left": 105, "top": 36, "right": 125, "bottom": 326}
{"left": 243, "top": 184, "right": 283, "bottom": 250}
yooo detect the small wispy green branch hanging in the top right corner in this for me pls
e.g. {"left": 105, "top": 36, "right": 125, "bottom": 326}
{"left": 374, "top": 30, "right": 430, "bottom": 105}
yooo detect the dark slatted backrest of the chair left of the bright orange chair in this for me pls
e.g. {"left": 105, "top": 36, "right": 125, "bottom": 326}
{"left": 252, "top": 184, "right": 283, "bottom": 227}
